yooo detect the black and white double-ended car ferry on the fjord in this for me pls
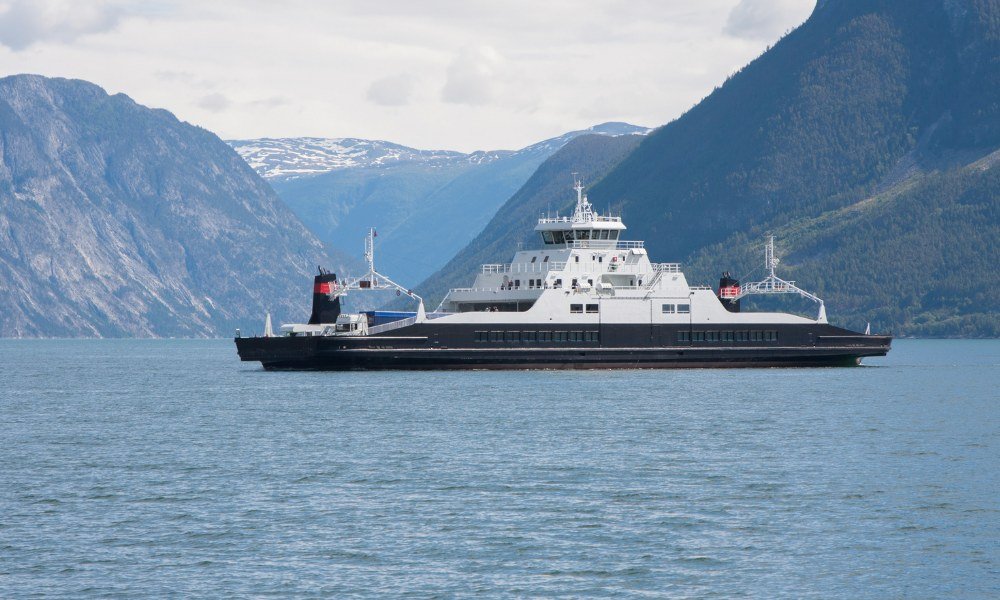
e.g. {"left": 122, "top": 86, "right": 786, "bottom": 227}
{"left": 235, "top": 181, "right": 892, "bottom": 370}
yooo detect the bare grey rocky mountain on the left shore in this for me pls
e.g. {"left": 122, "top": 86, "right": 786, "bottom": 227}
{"left": 0, "top": 75, "right": 352, "bottom": 337}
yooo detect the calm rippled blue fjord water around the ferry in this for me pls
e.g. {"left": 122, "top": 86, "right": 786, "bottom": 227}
{"left": 0, "top": 340, "right": 1000, "bottom": 598}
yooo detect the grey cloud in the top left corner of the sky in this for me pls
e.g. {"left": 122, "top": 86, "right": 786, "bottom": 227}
{"left": 0, "top": 0, "right": 123, "bottom": 51}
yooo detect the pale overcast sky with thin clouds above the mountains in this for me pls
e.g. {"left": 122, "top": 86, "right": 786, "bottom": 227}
{"left": 0, "top": 0, "right": 815, "bottom": 151}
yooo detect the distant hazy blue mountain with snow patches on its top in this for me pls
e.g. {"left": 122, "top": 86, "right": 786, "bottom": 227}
{"left": 230, "top": 123, "right": 648, "bottom": 285}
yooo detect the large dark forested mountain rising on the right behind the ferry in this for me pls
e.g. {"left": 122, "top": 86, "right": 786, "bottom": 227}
{"left": 423, "top": 0, "right": 1000, "bottom": 336}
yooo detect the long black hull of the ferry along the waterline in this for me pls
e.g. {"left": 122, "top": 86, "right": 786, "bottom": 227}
{"left": 236, "top": 324, "right": 892, "bottom": 371}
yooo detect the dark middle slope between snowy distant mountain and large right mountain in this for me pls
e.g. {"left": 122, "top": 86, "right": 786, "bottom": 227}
{"left": 416, "top": 135, "right": 641, "bottom": 307}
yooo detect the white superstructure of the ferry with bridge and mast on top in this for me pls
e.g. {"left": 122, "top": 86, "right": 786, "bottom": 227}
{"left": 435, "top": 181, "right": 825, "bottom": 324}
